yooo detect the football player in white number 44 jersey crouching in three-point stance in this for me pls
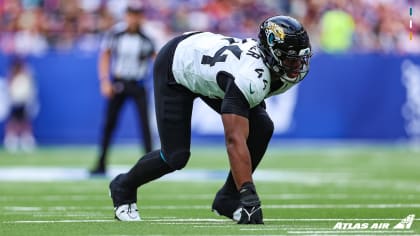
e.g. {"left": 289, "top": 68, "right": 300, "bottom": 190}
{"left": 110, "top": 16, "right": 312, "bottom": 224}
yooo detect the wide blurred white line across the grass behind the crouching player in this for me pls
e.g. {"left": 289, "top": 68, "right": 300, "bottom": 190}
{"left": 0, "top": 166, "right": 420, "bottom": 192}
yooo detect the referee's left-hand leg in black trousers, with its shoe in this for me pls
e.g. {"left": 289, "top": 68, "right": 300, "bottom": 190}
{"left": 91, "top": 93, "right": 126, "bottom": 175}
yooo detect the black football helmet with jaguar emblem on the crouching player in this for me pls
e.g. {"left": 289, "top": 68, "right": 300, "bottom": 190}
{"left": 258, "top": 16, "right": 312, "bottom": 83}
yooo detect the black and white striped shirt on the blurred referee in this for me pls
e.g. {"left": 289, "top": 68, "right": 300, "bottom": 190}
{"left": 101, "top": 23, "right": 154, "bottom": 80}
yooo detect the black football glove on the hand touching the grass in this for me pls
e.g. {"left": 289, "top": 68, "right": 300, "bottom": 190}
{"left": 238, "top": 182, "right": 264, "bottom": 224}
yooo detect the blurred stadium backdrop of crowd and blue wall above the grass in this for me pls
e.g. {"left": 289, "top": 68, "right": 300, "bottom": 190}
{"left": 0, "top": 0, "right": 420, "bottom": 150}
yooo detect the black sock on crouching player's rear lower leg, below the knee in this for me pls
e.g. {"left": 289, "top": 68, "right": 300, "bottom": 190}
{"left": 123, "top": 150, "right": 174, "bottom": 189}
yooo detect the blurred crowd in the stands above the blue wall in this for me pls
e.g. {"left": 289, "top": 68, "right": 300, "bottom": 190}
{"left": 0, "top": 0, "right": 420, "bottom": 55}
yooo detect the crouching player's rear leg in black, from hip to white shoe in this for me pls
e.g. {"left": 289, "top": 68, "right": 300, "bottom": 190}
{"left": 110, "top": 34, "right": 195, "bottom": 220}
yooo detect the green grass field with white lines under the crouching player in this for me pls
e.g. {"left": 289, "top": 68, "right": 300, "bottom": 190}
{"left": 0, "top": 145, "right": 420, "bottom": 236}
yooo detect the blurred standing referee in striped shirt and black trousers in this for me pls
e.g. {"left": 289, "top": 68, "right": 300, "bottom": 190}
{"left": 90, "top": 5, "right": 154, "bottom": 175}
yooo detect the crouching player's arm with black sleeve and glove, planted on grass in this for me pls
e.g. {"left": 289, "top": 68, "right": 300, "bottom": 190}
{"left": 218, "top": 74, "right": 263, "bottom": 224}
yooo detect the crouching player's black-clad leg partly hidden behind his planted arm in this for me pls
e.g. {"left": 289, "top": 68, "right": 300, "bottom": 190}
{"left": 212, "top": 105, "right": 274, "bottom": 218}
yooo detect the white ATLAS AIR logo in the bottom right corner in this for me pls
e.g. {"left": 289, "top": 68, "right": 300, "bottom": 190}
{"left": 333, "top": 214, "right": 415, "bottom": 231}
